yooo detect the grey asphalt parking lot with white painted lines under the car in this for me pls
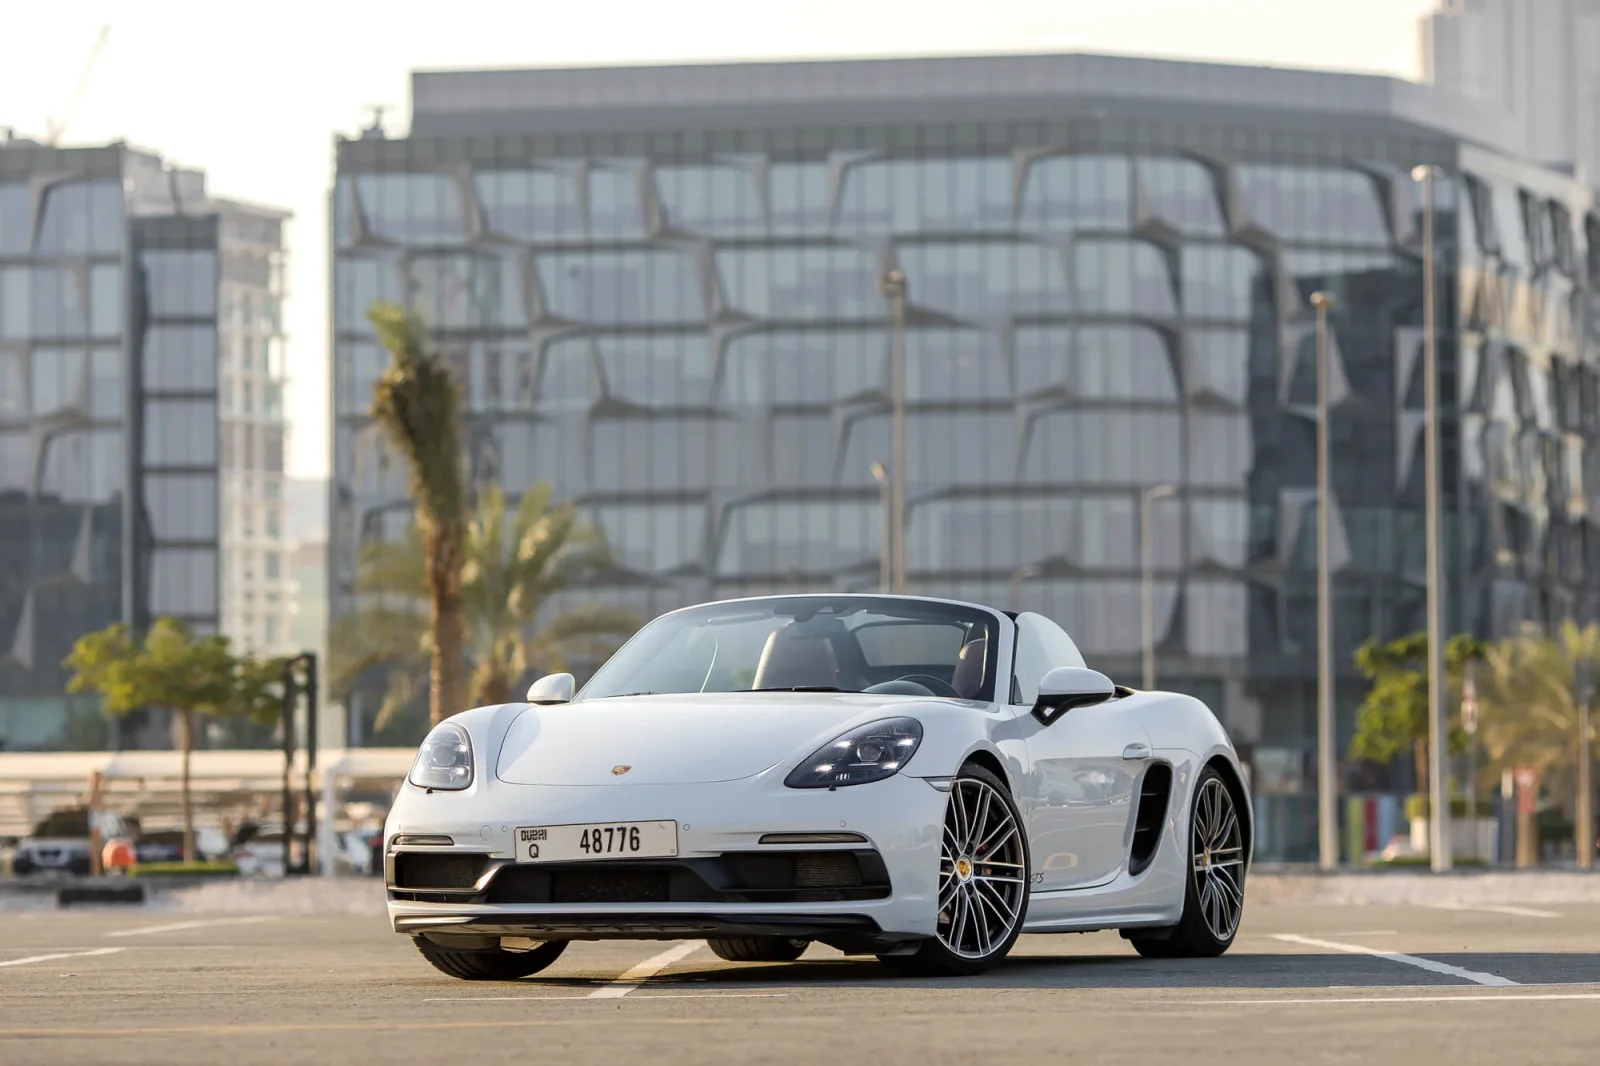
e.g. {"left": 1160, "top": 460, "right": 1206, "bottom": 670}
{"left": 0, "top": 904, "right": 1600, "bottom": 1066}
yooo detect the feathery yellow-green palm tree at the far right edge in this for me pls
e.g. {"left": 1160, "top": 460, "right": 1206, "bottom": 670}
{"left": 1480, "top": 621, "right": 1600, "bottom": 866}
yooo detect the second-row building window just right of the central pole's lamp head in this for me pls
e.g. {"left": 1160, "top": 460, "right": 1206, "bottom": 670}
{"left": 908, "top": 242, "right": 1070, "bottom": 322}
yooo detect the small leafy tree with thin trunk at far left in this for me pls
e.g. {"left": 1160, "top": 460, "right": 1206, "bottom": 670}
{"left": 62, "top": 618, "right": 282, "bottom": 861}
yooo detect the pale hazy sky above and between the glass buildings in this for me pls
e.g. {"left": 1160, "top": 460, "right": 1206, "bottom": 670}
{"left": 0, "top": 0, "right": 1437, "bottom": 477}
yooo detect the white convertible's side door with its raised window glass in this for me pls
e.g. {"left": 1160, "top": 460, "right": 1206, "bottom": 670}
{"left": 1011, "top": 613, "right": 1150, "bottom": 892}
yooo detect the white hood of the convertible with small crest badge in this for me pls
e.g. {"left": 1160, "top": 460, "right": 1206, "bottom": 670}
{"left": 496, "top": 691, "right": 925, "bottom": 784}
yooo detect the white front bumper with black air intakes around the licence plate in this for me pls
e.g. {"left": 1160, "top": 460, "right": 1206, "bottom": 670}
{"left": 384, "top": 775, "right": 947, "bottom": 951}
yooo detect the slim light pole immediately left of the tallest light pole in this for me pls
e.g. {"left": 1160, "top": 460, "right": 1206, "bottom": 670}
{"left": 1310, "top": 286, "right": 1339, "bottom": 871}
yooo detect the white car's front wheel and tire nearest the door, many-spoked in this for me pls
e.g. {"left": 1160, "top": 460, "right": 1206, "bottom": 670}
{"left": 878, "top": 763, "right": 1030, "bottom": 978}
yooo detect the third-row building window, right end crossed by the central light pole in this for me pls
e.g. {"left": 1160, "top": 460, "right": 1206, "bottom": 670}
{"left": 723, "top": 330, "right": 889, "bottom": 407}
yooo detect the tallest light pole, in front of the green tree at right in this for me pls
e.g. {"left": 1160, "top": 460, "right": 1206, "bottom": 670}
{"left": 1411, "top": 165, "right": 1454, "bottom": 874}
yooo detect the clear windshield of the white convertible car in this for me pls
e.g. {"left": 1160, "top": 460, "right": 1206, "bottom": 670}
{"left": 576, "top": 595, "right": 998, "bottom": 699}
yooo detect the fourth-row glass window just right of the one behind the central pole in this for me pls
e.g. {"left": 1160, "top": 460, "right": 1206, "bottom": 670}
{"left": 1022, "top": 408, "right": 1184, "bottom": 485}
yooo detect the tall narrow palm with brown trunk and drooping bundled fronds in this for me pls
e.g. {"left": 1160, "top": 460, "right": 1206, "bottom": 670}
{"left": 368, "top": 303, "right": 467, "bottom": 723}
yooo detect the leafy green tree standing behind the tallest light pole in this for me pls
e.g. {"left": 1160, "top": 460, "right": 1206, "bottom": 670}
{"left": 1350, "top": 632, "right": 1486, "bottom": 794}
